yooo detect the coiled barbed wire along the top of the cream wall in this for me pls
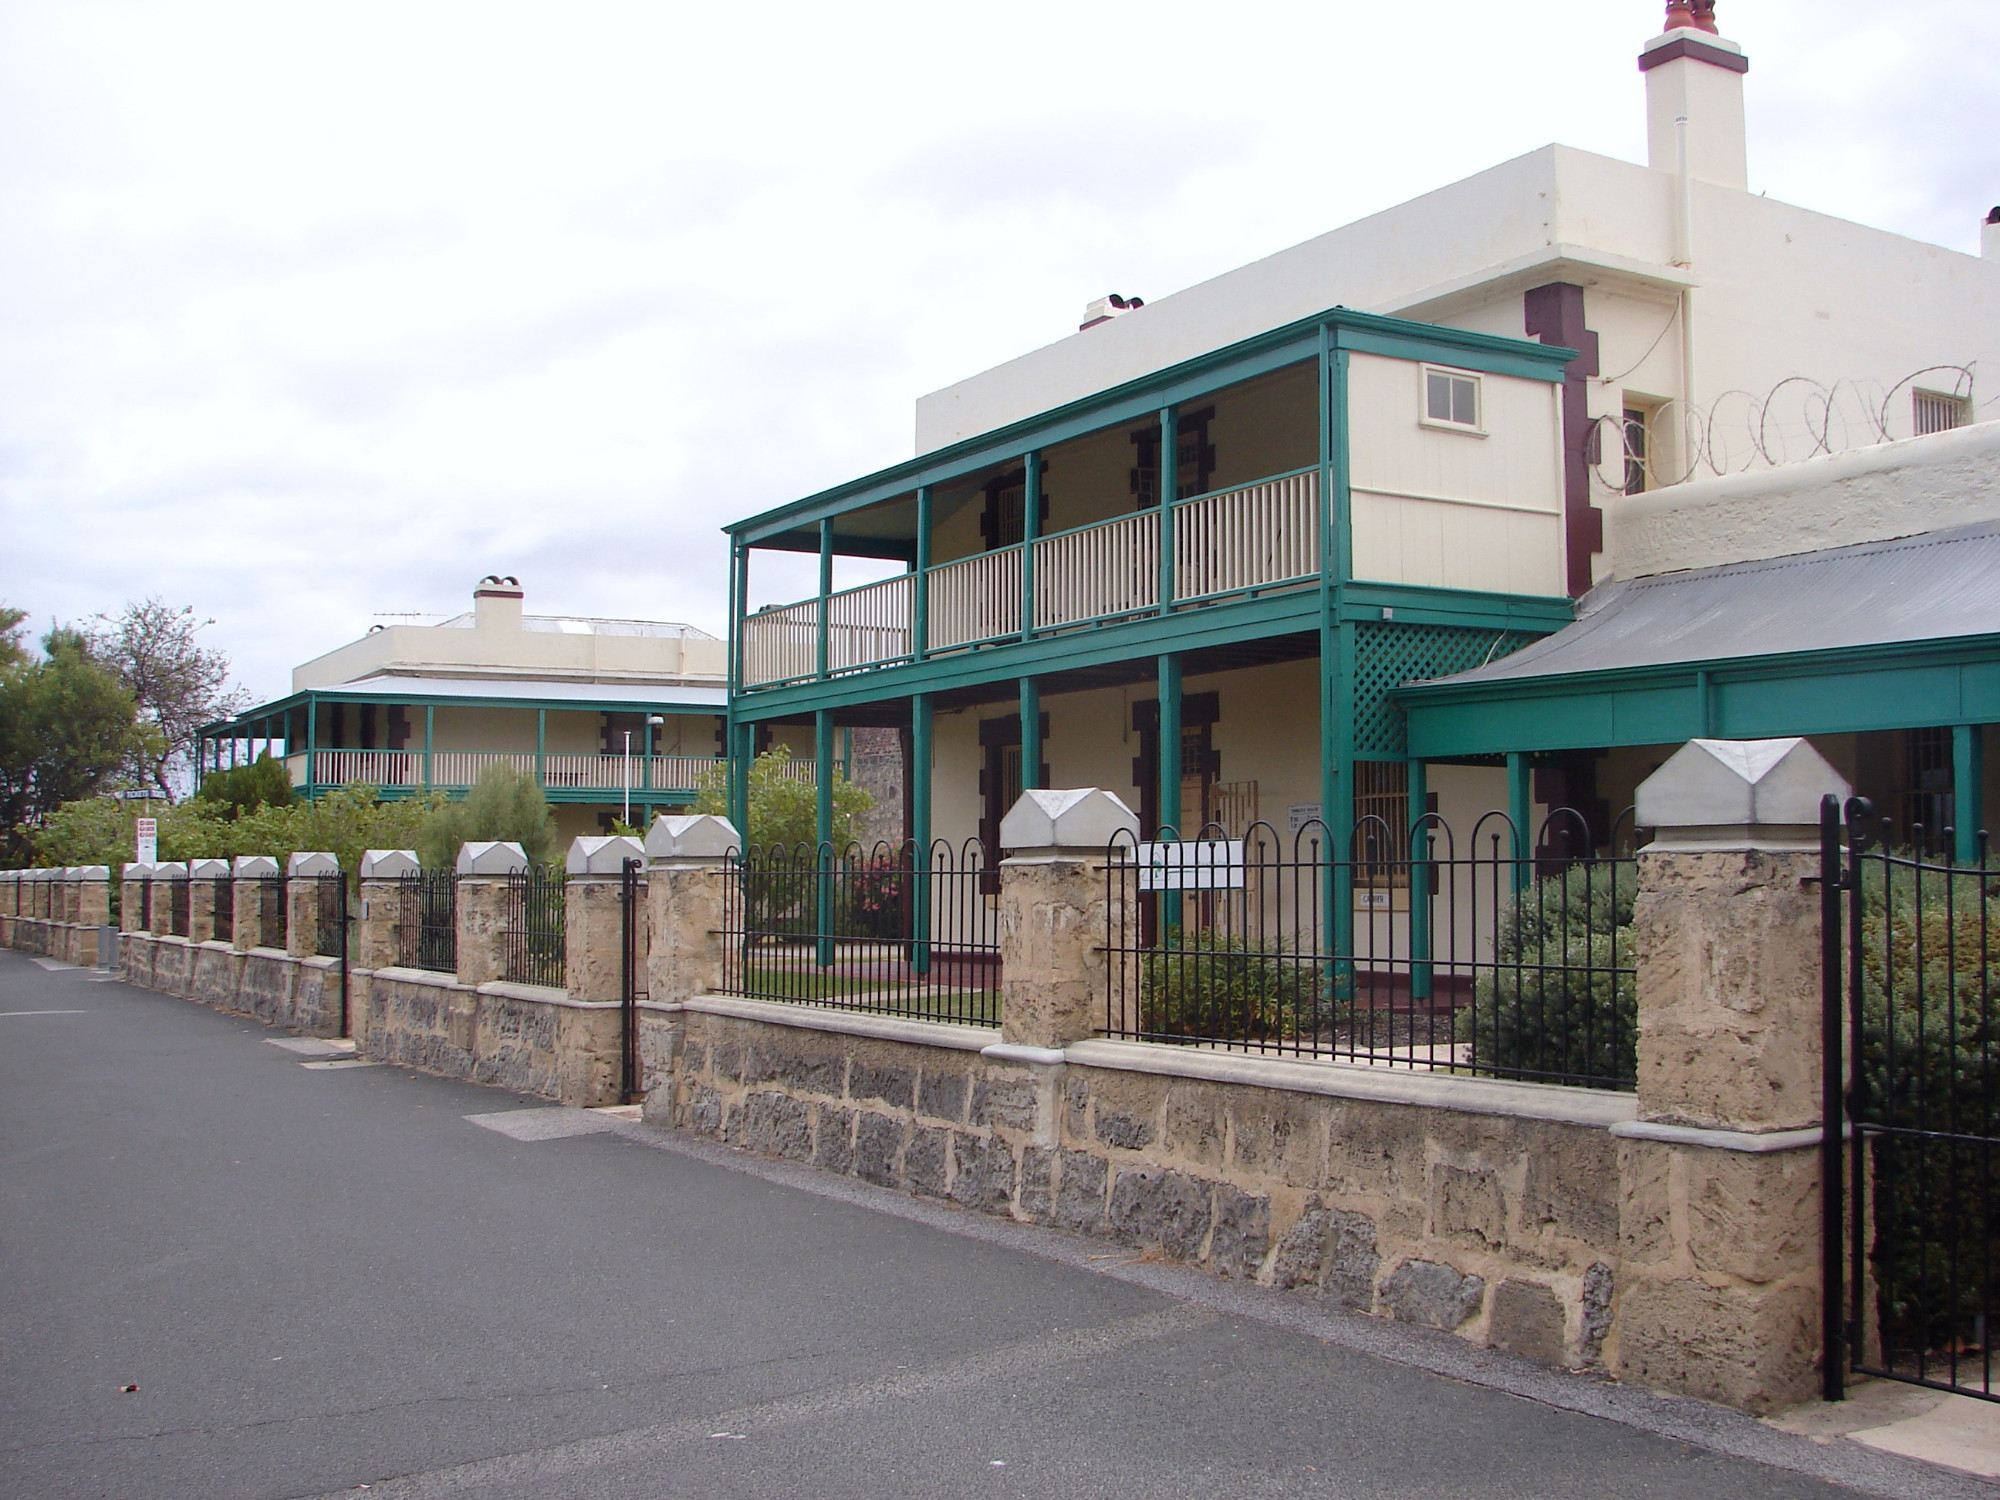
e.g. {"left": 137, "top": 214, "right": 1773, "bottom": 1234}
{"left": 1590, "top": 364, "right": 1992, "bottom": 494}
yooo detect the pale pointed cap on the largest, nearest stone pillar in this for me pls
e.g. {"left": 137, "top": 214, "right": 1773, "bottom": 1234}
{"left": 1632, "top": 738, "right": 1852, "bottom": 850}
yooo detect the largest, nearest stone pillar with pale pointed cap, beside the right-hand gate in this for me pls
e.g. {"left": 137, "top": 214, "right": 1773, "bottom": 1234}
{"left": 1606, "top": 740, "right": 1848, "bottom": 1412}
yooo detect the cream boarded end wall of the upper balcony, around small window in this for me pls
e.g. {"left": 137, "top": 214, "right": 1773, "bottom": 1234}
{"left": 1348, "top": 354, "right": 1564, "bottom": 594}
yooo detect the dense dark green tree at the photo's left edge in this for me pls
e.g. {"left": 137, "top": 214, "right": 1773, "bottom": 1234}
{"left": 0, "top": 626, "right": 158, "bottom": 860}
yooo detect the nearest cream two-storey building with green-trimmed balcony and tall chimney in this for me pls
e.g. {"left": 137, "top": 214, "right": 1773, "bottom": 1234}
{"left": 728, "top": 4, "right": 2000, "bottom": 880}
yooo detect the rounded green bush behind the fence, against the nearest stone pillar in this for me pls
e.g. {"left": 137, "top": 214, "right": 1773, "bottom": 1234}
{"left": 1456, "top": 864, "right": 1638, "bottom": 1084}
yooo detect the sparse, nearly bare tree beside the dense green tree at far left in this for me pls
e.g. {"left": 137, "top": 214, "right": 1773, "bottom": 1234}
{"left": 88, "top": 594, "right": 248, "bottom": 796}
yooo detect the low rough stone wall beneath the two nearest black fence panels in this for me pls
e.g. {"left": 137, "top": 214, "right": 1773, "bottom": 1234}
{"left": 646, "top": 1008, "right": 1620, "bottom": 1368}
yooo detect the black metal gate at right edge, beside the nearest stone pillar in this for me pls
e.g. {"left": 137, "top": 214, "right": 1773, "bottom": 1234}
{"left": 1820, "top": 798, "right": 2000, "bottom": 1400}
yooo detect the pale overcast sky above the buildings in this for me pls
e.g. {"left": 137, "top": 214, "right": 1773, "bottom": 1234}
{"left": 0, "top": 0, "right": 2000, "bottom": 696}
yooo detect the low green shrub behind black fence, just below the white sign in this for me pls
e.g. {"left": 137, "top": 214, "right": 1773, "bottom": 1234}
{"left": 1138, "top": 928, "right": 1334, "bottom": 1042}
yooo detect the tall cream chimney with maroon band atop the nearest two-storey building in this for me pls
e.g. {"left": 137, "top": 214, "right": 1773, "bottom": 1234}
{"left": 1638, "top": 0, "right": 1750, "bottom": 192}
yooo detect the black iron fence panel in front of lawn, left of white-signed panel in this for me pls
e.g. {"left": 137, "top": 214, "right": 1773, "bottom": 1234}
{"left": 722, "top": 840, "right": 1000, "bottom": 1026}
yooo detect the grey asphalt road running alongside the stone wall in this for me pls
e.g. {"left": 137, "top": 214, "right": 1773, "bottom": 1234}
{"left": 0, "top": 954, "right": 1996, "bottom": 1500}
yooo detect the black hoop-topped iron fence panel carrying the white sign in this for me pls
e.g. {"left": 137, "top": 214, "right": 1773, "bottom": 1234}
{"left": 1104, "top": 810, "right": 1638, "bottom": 1088}
